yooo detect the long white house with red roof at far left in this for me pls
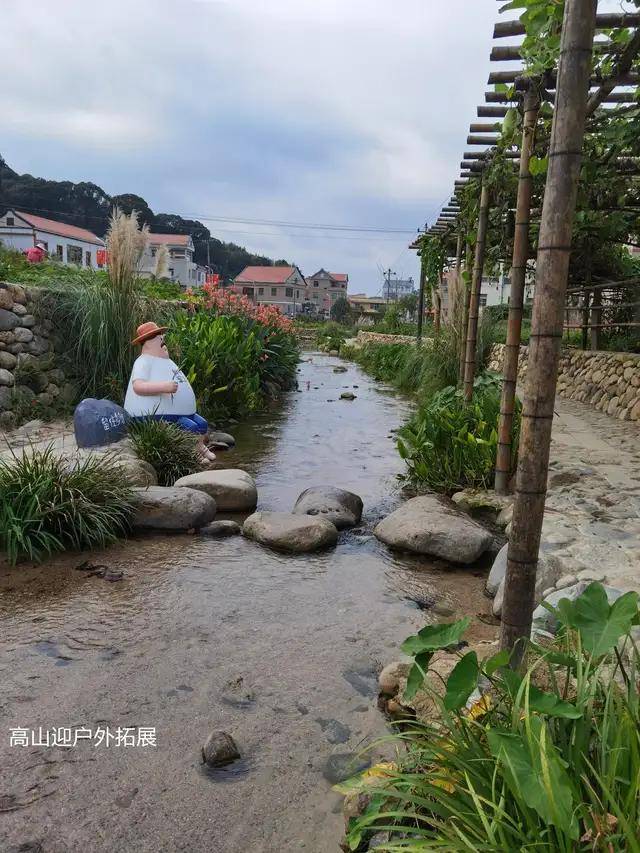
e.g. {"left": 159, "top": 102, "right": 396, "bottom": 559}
{"left": 0, "top": 210, "right": 104, "bottom": 269}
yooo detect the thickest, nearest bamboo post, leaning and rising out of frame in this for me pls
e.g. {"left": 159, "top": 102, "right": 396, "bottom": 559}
{"left": 501, "top": 0, "right": 596, "bottom": 666}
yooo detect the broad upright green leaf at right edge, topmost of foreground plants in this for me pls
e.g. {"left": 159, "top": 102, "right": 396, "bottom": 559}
{"left": 558, "top": 583, "right": 638, "bottom": 657}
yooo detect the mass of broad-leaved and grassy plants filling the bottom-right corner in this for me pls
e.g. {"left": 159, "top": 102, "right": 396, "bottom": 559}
{"left": 337, "top": 583, "right": 640, "bottom": 853}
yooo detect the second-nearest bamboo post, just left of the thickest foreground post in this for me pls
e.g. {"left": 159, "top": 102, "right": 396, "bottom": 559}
{"left": 495, "top": 80, "right": 540, "bottom": 495}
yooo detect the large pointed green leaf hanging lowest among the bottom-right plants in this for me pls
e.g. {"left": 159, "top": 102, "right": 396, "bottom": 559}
{"left": 487, "top": 716, "right": 578, "bottom": 839}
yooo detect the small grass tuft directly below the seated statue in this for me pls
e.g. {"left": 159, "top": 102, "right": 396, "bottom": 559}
{"left": 129, "top": 418, "right": 202, "bottom": 486}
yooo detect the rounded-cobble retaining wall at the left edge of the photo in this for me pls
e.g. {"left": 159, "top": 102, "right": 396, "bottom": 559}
{"left": 0, "top": 282, "right": 75, "bottom": 429}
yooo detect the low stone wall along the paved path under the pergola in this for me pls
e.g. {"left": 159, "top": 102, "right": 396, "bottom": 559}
{"left": 489, "top": 344, "right": 640, "bottom": 421}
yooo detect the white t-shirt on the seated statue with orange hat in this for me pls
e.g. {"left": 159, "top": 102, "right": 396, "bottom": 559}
{"left": 124, "top": 355, "right": 196, "bottom": 417}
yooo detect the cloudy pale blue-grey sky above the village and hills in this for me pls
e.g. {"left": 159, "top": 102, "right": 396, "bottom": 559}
{"left": 0, "top": 0, "right": 508, "bottom": 294}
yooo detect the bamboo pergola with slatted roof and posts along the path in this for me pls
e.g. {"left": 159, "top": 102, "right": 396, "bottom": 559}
{"left": 410, "top": 0, "right": 640, "bottom": 652}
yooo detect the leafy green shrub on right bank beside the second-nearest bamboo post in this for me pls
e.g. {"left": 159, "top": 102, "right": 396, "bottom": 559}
{"left": 398, "top": 374, "right": 520, "bottom": 493}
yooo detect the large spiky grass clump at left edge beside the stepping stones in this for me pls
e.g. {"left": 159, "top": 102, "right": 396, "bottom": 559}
{"left": 0, "top": 447, "right": 134, "bottom": 564}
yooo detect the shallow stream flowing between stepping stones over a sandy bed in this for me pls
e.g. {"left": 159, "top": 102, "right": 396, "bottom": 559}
{"left": 0, "top": 353, "right": 496, "bottom": 853}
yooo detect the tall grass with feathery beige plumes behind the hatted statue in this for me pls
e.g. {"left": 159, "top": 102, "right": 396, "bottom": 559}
{"left": 56, "top": 210, "right": 149, "bottom": 400}
